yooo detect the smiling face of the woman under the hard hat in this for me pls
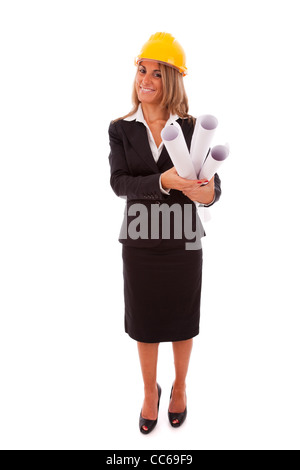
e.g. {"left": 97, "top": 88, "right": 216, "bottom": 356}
{"left": 135, "top": 60, "right": 163, "bottom": 104}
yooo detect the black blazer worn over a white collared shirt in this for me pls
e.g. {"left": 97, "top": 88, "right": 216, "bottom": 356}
{"left": 109, "top": 119, "right": 221, "bottom": 249}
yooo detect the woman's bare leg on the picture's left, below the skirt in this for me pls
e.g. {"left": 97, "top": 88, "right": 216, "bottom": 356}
{"left": 137, "top": 342, "right": 159, "bottom": 431}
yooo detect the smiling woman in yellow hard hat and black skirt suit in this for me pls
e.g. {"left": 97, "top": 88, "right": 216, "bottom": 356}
{"left": 109, "top": 33, "right": 221, "bottom": 434}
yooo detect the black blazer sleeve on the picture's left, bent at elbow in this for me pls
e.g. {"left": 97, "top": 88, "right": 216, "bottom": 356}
{"left": 108, "top": 123, "right": 168, "bottom": 200}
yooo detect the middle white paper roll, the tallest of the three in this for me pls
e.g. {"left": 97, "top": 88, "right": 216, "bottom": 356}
{"left": 191, "top": 114, "right": 218, "bottom": 176}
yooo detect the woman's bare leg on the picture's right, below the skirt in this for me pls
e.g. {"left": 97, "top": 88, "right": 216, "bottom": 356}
{"left": 169, "top": 339, "right": 193, "bottom": 424}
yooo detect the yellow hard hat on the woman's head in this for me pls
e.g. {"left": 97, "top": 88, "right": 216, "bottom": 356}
{"left": 135, "top": 33, "right": 187, "bottom": 76}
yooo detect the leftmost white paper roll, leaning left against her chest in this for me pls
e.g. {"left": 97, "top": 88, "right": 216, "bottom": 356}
{"left": 161, "top": 123, "right": 197, "bottom": 180}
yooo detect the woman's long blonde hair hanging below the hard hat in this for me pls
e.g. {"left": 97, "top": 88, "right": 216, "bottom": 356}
{"left": 114, "top": 63, "right": 195, "bottom": 123}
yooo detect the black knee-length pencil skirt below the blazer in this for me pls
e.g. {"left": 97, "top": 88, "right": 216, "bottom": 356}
{"left": 122, "top": 241, "right": 202, "bottom": 343}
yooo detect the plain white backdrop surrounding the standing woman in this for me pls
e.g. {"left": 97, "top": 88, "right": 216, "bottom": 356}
{"left": 0, "top": 0, "right": 300, "bottom": 450}
